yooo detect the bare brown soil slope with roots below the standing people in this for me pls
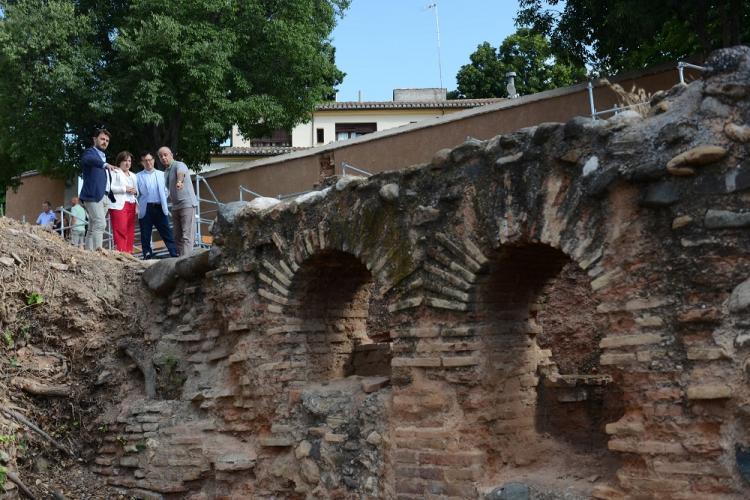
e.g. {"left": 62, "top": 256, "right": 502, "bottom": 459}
{"left": 0, "top": 218, "right": 145, "bottom": 499}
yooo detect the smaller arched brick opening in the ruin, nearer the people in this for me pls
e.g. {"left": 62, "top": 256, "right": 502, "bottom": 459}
{"left": 292, "top": 250, "right": 391, "bottom": 382}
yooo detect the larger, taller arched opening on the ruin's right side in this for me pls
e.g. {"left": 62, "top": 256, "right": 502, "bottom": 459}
{"left": 475, "top": 244, "right": 623, "bottom": 484}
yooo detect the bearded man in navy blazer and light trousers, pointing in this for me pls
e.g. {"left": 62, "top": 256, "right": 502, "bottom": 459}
{"left": 78, "top": 129, "right": 115, "bottom": 250}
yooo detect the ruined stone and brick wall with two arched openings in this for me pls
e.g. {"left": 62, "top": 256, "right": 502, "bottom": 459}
{"left": 92, "top": 48, "right": 750, "bottom": 500}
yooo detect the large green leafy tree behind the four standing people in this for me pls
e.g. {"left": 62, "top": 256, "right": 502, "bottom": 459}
{"left": 0, "top": 0, "right": 349, "bottom": 189}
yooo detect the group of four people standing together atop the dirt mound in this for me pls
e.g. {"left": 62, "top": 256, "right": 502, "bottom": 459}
{"left": 79, "top": 129, "right": 198, "bottom": 259}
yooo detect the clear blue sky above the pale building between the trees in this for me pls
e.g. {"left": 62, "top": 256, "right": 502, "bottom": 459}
{"left": 332, "top": 0, "right": 518, "bottom": 101}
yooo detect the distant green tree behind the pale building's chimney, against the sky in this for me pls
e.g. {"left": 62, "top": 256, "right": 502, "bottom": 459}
{"left": 451, "top": 28, "right": 586, "bottom": 99}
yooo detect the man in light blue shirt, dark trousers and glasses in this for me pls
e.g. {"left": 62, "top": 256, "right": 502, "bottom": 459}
{"left": 135, "top": 151, "right": 177, "bottom": 259}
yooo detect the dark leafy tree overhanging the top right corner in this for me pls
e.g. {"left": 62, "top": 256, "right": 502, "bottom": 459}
{"left": 516, "top": 0, "right": 750, "bottom": 73}
